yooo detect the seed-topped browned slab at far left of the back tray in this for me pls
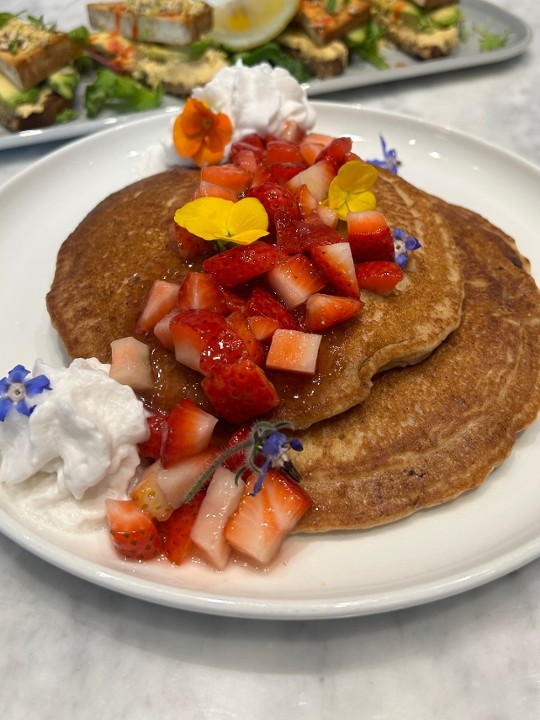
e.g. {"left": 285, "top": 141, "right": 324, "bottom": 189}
{"left": 0, "top": 16, "right": 77, "bottom": 90}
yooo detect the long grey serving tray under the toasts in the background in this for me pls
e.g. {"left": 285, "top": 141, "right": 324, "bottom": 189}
{"left": 0, "top": 0, "right": 532, "bottom": 150}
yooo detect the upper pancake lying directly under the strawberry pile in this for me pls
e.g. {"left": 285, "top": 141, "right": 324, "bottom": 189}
{"left": 47, "top": 169, "right": 463, "bottom": 428}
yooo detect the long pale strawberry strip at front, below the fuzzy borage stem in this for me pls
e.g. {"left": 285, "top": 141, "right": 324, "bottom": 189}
{"left": 191, "top": 467, "right": 244, "bottom": 570}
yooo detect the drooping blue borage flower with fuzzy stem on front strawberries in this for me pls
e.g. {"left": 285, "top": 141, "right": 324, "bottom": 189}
{"left": 184, "top": 420, "right": 303, "bottom": 502}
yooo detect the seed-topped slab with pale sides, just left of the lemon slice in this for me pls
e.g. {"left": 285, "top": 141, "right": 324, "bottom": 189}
{"left": 87, "top": 0, "right": 213, "bottom": 45}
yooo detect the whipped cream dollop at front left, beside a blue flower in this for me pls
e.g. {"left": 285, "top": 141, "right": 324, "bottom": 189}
{"left": 0, "top": 358, "right": 148, "bottom": 525}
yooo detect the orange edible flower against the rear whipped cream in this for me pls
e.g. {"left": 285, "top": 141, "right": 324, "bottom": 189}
{"left": 173, "top": 98, "right": 233, "bottom": 167}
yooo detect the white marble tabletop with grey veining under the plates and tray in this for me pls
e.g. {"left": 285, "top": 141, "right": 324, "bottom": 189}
{"left": 0, "top": 0, "right": 540, "bottom": 720}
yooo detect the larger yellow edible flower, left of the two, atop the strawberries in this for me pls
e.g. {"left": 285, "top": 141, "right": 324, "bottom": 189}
{"left": 174, "top": 197, "right": 268, "bottom": 245}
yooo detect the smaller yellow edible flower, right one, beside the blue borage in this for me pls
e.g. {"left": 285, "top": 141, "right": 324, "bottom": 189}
{"left": 328, "top": 160, "right": 379, "bottom": 220}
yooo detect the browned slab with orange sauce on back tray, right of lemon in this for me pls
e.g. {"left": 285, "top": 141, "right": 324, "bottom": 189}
{"left": 297, "top": 0, "right": 370, "bottom": 46}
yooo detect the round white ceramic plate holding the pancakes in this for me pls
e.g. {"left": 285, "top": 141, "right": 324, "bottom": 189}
{"left": 0, "top": 102, "right": 540, "bottom": 619}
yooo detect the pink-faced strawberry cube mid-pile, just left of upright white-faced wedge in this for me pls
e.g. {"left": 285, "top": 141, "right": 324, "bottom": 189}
{"left": 267, "top": 255, "right": 327, "bottom": 308}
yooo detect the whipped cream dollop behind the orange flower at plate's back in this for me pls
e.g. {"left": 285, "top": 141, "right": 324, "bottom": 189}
{"left": 139, "top": 60, "right": 316, "bottom": 176}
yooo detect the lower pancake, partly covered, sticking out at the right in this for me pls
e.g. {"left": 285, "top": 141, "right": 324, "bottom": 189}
{"left": 295, "top": 201, "right": 540, "bottom": 532}
